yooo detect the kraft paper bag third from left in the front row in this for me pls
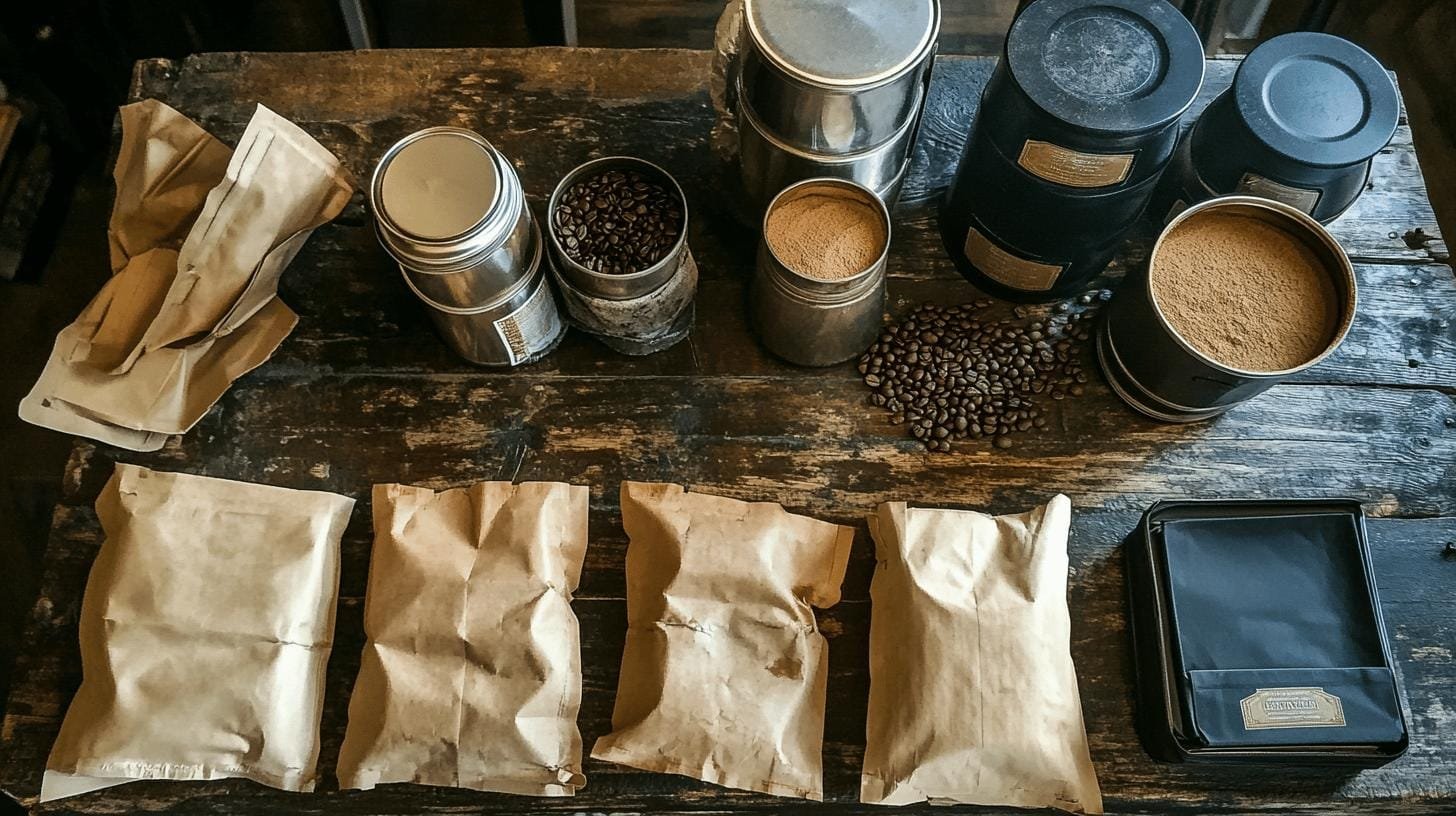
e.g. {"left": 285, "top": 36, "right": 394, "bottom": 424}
{"left": 591, "top": 482, "right": 855, "bottom": 800}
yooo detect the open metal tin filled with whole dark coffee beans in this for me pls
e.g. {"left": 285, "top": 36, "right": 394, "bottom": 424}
{"left": 546, "top": 156, "right": 697, "bottom": 354}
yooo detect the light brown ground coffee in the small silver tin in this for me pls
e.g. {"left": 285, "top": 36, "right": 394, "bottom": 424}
{"left": 764, "top": 192, "right": 885, "bottom": 280}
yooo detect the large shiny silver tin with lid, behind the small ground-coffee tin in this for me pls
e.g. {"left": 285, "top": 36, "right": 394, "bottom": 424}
{"left": 737, "top": 0, "right": 941, "bottom": 208}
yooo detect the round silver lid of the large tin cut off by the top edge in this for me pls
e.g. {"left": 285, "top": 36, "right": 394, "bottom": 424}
{"left": 744, "top": 0, "right": 941, "bottom": 87}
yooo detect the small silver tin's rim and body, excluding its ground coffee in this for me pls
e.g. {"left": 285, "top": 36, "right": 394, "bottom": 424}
{"left": 751, "top": 178, "right": 890, "bottom": 366}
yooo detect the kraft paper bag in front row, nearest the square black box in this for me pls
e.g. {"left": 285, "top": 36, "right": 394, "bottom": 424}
{"left": 859, "top": 495, "right": 1102, "bottom": 813}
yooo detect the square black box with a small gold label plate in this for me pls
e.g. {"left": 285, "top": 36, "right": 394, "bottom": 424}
{"left": 1124, "top": 500, "right": 1408, "bottom": 768}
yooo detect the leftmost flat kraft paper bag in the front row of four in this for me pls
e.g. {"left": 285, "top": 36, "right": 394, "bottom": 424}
{"left": 41, "top": 465, "right": 354, "bottom": 801}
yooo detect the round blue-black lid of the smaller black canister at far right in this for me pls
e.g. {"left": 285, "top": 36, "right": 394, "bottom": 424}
{"left": 1233, "top": 32, "right": 1401, "bottom": 168}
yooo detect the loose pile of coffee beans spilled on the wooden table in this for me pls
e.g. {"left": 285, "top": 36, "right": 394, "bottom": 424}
{"left": 859, "top": 290, "right": 1112, "bottom": 452}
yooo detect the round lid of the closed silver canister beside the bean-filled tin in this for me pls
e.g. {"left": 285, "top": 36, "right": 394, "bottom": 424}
{"left": 374, "top": 128, "right": 501, "bottom": 240}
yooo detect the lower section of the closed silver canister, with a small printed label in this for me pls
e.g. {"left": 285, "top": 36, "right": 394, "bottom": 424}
{"left": 403, "top": 224, "right": 566, "bottom": 366}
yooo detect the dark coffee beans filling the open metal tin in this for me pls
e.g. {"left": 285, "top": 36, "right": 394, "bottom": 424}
{"left": 552, "top": 170, "right": 683, "bottom": 275}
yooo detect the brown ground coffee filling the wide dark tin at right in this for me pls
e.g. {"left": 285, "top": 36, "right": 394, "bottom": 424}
{"left": 1152, "top": 213, "right": 1340, "bottom": 372}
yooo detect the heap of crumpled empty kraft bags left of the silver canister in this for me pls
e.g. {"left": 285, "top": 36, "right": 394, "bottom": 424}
{"left": 20, "top": 101, "right": 352, "bottom": 450}
